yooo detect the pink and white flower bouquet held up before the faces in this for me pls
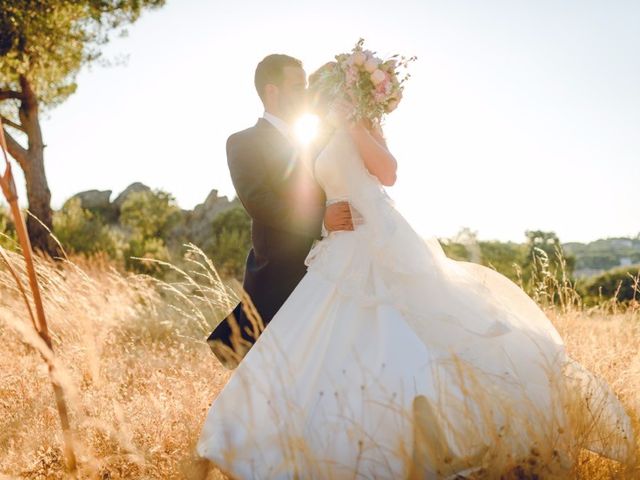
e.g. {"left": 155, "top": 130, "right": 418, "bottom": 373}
{"left": 320, "top": 38, "right": 417, "bottom": 123}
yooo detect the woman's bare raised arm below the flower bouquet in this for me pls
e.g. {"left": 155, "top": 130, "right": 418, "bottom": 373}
{"left": 349, "top": 122, "right": 398, "bottom": 186}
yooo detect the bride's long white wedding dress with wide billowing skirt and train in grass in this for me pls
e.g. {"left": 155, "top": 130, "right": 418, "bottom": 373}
{"left": 197, "top": 130, "right": 634, "bottom": 479}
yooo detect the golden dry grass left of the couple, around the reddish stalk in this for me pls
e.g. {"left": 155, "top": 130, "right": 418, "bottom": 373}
{"left": 0, "top": 246, "right": 228, "bottom": 478}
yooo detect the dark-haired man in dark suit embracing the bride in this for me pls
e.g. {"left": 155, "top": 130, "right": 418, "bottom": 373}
{"left": 207, "top": 54, "right": 353, "bottom": 368}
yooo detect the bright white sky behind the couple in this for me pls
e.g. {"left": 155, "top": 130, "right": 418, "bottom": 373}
{"left": 6, "top": 0, "right": 640, "bottom": 241}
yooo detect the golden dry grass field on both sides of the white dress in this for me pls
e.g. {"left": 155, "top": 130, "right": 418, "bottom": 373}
{"left": 0, "top": 249, "right": 640, "bottom": 479}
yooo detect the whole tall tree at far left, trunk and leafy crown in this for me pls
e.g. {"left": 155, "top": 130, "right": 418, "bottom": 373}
{"left": 0, "top": 0, "right": 164, "bottom": 256}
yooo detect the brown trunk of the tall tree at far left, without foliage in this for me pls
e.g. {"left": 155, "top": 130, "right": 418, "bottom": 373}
{"left": 7, "top": 76, "right": 62, "bottom": 257}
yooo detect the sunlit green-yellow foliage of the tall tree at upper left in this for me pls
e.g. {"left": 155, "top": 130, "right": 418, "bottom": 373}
{"left": 0, "top": 0, "right": 164, "bottom": 106}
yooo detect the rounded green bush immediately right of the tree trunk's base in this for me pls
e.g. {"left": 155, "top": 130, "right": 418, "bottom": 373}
{"left": 53, "top": 198, "right": 119, "bottom": 258}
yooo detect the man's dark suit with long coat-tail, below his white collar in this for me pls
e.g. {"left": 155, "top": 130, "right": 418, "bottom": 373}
{"left": 207, "top": 118, "right": 325, "bottom": 367}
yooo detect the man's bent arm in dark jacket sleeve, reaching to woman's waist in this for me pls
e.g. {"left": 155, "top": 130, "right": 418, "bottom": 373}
{"left": 227, "top": 135, "right": 324, "bottom": 236}
